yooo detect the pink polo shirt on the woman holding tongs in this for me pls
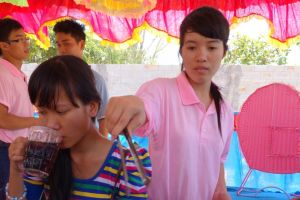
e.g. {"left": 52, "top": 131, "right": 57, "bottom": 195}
{"left": 137, "top": 72, "right": 233, "bottom": 200}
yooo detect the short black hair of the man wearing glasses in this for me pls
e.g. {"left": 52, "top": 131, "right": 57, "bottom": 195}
{"left": 0, "top": 18, "right": 23, "bottom": 56}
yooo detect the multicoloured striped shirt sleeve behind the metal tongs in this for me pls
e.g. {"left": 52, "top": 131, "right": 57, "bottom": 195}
{"left": 118, "top": 148, "right": 152, "bottom": 200}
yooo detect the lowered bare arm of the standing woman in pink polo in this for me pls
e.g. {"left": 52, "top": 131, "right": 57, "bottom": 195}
{"left": 213, "top": 164, "right": 231, "bottom": 200}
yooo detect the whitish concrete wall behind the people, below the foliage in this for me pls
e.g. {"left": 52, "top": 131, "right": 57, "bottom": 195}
{"left": 22, "top": 64, "right": 300, "bottom": 111}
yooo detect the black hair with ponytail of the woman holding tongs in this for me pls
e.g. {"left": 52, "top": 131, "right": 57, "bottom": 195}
{"left": 179, "top": 6, "right": 229, "bottom": 134}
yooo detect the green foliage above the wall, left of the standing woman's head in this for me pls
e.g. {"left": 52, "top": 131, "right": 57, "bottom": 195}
{"left": 27, "top": 28, "right": 165, "bottom": 64}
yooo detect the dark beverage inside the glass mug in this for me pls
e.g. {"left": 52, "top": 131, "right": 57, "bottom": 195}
{"left": 24, "top": 141, "right": 59, "bottom": 177}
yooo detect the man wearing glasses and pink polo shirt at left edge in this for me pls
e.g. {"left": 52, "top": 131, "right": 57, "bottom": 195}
{"left": 0, "top": 18, "right": 43, "bottom": 199}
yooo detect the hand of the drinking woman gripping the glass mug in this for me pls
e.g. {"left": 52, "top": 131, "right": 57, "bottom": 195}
{"left": 8, "top": 137, "right": 28, "bottom": 172}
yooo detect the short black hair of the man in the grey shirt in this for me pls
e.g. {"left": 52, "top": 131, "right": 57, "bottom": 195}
{"left": 53, "top": 19, "right": 85, "bottom": 42}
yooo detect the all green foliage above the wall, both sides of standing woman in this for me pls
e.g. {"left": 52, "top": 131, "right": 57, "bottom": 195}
{"left": 27, "top": 27, "right": 292, "bottom": 65}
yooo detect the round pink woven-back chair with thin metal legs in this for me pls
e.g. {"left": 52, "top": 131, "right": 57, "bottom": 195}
{"left": 237, "top": 83, "right": 300, "bottom": 196}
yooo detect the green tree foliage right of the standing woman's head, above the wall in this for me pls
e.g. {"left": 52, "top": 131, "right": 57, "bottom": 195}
{"left": 224, "top": 34, "right": 290, "bottom": 65}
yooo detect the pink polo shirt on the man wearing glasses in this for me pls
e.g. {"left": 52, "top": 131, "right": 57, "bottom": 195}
{"left": 0, "top": 58, "right": 33, "bottom": 143}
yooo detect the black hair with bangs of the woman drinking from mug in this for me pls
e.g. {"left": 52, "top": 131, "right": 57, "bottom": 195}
{"left": 28, "top": 55, "right": 100, "bottom": 200}
